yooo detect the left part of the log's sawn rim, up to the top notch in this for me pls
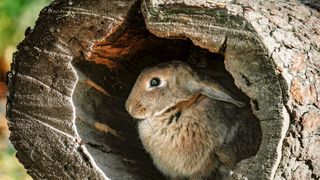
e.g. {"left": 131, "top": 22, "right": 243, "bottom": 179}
{"left": 7, "top": 0, "right": 138, "bottom": 179}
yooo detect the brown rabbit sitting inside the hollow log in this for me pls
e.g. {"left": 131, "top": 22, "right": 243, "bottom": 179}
{"left": 126, "top": 61, "right": 245, "bottom": 179}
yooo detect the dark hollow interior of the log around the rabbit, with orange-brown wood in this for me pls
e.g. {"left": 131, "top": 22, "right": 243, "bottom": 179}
{"left": 73, "top": 3, "right": 261, "bottom": 179}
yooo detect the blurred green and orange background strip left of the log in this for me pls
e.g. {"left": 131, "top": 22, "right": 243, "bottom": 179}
{"left": 0, "top": 0, "right": 51, "bottom": 180}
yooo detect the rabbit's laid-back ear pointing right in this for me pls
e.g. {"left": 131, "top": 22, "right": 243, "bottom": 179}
{"left": 190, "top": 80, "right": 245, "bottom": 108}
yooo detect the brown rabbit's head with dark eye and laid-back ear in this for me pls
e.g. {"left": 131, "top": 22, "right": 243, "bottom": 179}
{"left": 125, "top": 61, "right": 244, "bottom": 119}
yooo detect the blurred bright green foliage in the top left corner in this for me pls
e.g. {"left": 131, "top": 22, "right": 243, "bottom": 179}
{"left": 0, "top": 0, "right": 50, "bottom": 57}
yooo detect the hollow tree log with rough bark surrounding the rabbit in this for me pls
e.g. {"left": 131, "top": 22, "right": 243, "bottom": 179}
{"left": 7, "top": 0, "right": 320, "bottom": 179}
